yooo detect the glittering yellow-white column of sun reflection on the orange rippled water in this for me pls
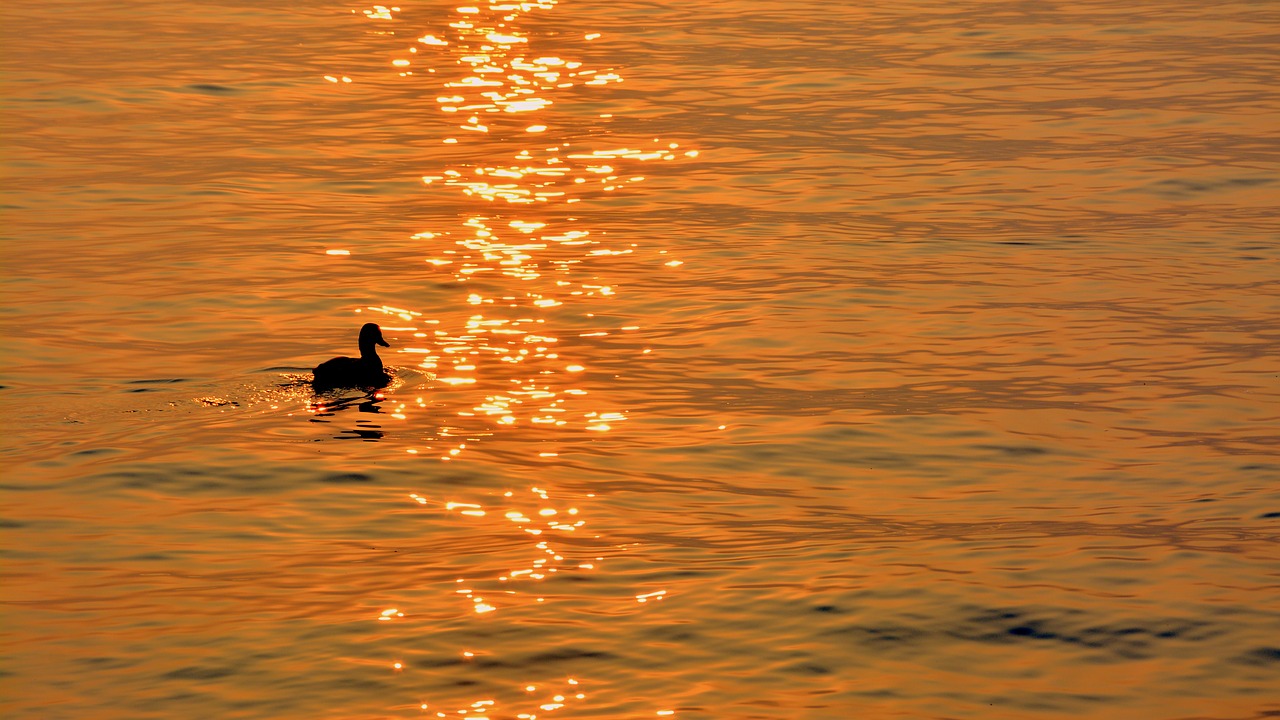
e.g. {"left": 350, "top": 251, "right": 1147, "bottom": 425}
{"left": 325, "top": 0, "right": 698, "bottom": 719}
